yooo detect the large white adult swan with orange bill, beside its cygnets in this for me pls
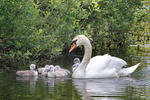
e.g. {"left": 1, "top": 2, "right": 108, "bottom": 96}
{"left": 69, "top": 35, "right": 140, "bottom": 78}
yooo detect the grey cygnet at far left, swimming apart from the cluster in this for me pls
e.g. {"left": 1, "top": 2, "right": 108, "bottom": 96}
{"left": 16, "top": 64, "right": 38, "bottom": 76}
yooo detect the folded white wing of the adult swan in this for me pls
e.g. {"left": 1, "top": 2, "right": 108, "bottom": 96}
{"left": 86, "top": 54, "right": 127, "bottom": 74}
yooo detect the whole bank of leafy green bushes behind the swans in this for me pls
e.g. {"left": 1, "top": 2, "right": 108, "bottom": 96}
{"left": 0, "top": 0, "right": 150, "bottom": 70}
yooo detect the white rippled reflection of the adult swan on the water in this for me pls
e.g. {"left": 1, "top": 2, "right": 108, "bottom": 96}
{"left": 73, "top": 77, "right": 135, "bottom": 100}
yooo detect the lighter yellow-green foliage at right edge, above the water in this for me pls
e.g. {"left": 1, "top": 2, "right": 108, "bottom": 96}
{"left": 131, "top": 0, "right": 150, "bottom": 43}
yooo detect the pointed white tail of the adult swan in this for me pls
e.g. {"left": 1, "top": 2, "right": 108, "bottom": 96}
{"left": 119, "top": 63, "right": 140, "bottom": 76}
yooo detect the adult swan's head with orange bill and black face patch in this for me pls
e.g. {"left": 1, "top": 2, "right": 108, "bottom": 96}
{"left": 69, "top": 35, "right": 90, "bottom": 52}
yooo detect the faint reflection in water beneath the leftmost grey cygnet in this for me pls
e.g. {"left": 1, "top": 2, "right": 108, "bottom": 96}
{"left": 16, "top": 76, "right": 38, "bottom": 92}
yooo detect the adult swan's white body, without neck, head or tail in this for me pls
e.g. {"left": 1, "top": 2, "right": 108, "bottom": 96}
{"left": 86, "top": 54, "right": 127, "bottom": 78}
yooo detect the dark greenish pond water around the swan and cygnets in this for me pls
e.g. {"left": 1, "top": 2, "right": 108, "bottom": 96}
{"left": 0, "top": 44, "right": 150, "bottom": 100}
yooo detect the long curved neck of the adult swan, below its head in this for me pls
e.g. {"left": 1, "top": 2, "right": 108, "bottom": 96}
{"left": 73, "top": 40, "right": 92, "bottom": 78}
